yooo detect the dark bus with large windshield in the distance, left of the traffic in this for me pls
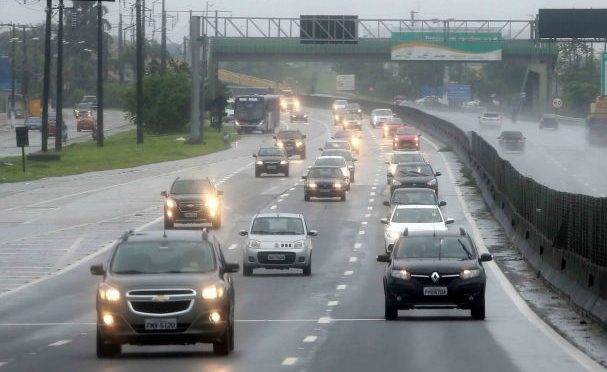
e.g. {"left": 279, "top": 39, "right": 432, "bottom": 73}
{"left": 234, "top": 94, "right": 280, "bottom": 134}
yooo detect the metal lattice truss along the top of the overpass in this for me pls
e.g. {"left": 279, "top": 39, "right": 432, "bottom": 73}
{"left": 201, "top": 16, "right": 536, "bottom": 40}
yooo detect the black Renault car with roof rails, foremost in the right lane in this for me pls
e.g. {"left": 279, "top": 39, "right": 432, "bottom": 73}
{"left": 377, "top": 228, "right": 492, "bottom": 320}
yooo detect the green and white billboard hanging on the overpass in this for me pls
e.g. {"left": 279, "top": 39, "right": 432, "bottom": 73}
{"left": 391, "top": 32, "right": 502, "bottom": 62}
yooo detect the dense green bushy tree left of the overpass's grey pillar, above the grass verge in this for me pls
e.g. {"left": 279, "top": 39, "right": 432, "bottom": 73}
{"left": 123, "top": 69, "right": 191, "bottom": 133}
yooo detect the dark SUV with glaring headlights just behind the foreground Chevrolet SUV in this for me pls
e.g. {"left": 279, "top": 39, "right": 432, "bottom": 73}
{"left": 160, "top": 178, "right": 223, "bottom": 229}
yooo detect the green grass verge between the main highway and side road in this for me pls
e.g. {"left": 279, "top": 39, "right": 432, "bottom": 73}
{"left": 0, "top": 128, "right": 232, "bottom": 183}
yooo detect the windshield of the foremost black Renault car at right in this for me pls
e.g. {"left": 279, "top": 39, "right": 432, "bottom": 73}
{"left": 393, "top": 236, "right": 476, "bottom": 260}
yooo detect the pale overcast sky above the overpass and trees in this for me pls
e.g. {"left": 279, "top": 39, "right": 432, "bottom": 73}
{"left": 0, "top": 0, "right": 607, "bottom": 42}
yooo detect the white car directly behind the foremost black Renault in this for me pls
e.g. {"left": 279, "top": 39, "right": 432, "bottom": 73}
{"left": 380, "top": 204, "right": 454, "bottom": 253}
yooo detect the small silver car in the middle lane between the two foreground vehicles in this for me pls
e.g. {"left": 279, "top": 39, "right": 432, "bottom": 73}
{"left": 240, "top": 213, "right": 318, "bottom": 276}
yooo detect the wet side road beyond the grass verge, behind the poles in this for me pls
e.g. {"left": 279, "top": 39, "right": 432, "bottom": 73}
{"left": 0, "top": 109, "right": 134, "bottom": 157}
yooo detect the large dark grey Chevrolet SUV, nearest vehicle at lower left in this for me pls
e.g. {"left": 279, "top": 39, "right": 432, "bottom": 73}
{"left": 91, "top": 229, "right": 239, "bottom": 358}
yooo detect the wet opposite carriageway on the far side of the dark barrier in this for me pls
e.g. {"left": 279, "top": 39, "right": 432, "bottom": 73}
{"left": 423, "top": 109, "right": 607, "bottom": 197}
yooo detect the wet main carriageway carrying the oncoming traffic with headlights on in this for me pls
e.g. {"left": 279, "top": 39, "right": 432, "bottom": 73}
{"left": 0, "top": 109, "right": 602, "bottom": 372}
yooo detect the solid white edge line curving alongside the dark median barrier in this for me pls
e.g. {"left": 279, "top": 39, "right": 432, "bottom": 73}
{"left": 424, "top": 138, "right": 603, "bottom": 371}
